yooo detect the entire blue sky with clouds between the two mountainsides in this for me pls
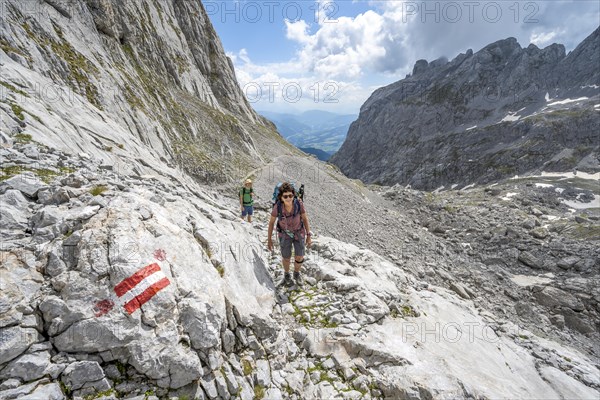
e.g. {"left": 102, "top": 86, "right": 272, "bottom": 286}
{"left": 203, "top": 0, "right": 600, "bottom": 113}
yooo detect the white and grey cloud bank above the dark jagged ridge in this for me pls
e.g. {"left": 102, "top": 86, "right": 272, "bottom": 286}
{"left": 230, "top": 0, "right": 600, "bottom": 112}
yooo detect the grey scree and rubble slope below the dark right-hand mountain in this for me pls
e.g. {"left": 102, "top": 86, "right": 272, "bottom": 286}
{"left": 247, "top": 156, "right": 600, "bottom": 368}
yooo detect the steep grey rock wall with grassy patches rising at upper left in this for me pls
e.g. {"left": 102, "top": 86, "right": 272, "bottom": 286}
{"left": 0, "top": 0, "right": 286, "bottom": 182}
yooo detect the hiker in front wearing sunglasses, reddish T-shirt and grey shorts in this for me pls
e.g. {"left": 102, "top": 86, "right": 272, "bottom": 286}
{"left": 267, "top": 182, "right": 312, "bottom": 287}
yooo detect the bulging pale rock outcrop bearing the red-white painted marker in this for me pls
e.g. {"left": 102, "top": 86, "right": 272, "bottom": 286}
{"left": 0, "top": 143, "right": 279, "bottom": 399}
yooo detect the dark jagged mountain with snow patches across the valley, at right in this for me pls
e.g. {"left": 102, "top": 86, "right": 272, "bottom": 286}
{"left": 331, "top": 29, "right": 600, "bottom": 189}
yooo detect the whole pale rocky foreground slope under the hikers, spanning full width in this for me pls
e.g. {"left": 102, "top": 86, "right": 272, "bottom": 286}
{"left": 0, "top": 138, "right": 600, "bottom": 399}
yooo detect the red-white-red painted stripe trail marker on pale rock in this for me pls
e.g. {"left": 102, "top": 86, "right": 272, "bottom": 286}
{"left": 114, "top": 263, "right": 171, "bottom": 314}
